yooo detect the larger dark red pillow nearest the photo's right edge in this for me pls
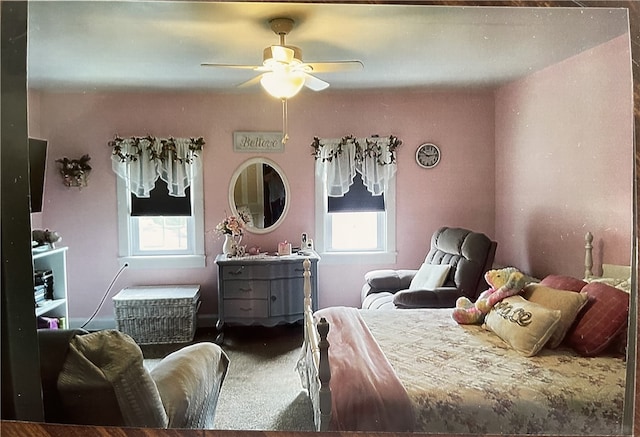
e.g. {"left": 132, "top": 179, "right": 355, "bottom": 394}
{"left": 565, "top": 282, "right": 629, "bottom": 357}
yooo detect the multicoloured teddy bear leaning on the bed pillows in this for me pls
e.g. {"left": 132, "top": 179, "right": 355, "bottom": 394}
{"left": 452, "top": 267, "right": 526, "bottom": 325}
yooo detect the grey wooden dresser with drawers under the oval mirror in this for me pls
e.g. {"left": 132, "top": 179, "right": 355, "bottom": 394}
{"left": 216, "top": 251, "right": 320, "bottom": 341}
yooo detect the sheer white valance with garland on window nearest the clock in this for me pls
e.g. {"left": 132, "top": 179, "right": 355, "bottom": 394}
{"left": 311, "top": 135, "right": 402, "bottom": 197}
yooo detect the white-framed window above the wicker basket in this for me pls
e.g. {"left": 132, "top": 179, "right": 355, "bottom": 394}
{"left": 114, "top": 135, "right": 205, "bottom": 268}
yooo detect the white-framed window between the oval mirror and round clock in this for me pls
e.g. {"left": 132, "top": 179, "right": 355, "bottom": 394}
{"left": 316, "top": 137, "right": 396, "bottom": 263}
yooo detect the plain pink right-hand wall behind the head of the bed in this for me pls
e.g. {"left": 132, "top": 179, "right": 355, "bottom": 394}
{"left": 495, "top": 35, "right": 633, "bottom": 277}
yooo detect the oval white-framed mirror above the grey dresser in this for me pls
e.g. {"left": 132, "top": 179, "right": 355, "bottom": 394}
{"left": 229, "top": 157, "right": 290, "bottom": 234}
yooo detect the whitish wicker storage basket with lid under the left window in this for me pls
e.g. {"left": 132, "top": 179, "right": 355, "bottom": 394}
{"left": 113, "top": 285, "right": 200, "bottom": 344}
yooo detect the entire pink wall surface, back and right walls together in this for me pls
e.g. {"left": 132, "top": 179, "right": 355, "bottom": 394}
{"left": 29, "top": 35, "right": 633, "bottom": 322}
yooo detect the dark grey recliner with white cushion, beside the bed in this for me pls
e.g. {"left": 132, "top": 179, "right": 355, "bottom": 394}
{"left": 362, "top": 227, "right": 497, "bottom": 309}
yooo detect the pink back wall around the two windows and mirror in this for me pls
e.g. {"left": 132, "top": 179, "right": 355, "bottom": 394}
{"left": 30, "top": 91, "right": 495, "bottom": 322}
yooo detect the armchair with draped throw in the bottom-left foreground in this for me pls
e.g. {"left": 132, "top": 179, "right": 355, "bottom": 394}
{"left": 38, "top": 330, "right": 229, "bottom": 428}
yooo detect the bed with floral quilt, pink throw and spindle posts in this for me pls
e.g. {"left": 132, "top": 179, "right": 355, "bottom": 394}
{"left": 298, "top": 234, "right": 631, "bottom": 435}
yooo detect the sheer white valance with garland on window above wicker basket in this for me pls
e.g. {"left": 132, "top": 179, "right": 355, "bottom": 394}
{"left": 109, "top": 136, "right": 204, "bottom": 197}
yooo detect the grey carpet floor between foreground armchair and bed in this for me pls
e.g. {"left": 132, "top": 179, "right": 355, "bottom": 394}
{"left": 142, "top": 324, "right": 314, "bottom": 431}
